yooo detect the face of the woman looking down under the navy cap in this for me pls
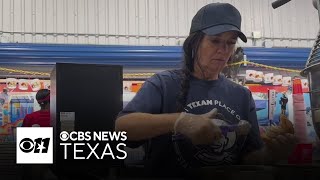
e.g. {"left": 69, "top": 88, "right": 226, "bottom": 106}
{"left": 194, "top": 31, "right": 238, "bottom": 80}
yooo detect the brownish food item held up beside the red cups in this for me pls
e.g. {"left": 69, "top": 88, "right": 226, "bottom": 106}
{"left": 261, "top": 114, "right": 294, "bottom": 143}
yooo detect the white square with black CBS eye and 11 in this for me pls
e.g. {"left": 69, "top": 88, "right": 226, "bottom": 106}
{"left": 16, "top": 127, "right": 53, "bottom": 164}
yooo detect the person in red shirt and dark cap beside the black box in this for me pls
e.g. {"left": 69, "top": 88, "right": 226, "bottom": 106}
{"left": 22, "top": 89, "right": 50, "bottom": 127}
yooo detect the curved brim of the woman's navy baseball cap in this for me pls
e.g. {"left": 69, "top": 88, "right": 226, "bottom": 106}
{"left": 202, "top": 24, "right": 247, "bottom": 42}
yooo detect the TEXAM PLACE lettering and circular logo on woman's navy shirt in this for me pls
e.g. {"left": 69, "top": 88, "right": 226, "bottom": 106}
{"left": 172, "top": 99, "right": 246, "bottom": 168}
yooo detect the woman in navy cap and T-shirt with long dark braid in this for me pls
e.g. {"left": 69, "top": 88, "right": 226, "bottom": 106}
{"left": 116, "top": 3, "right": 295, "bottom": 176}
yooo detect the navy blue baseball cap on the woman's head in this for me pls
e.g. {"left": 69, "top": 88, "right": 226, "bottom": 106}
{"left": 190, "top": 3, "right": 247, "bottom": 42}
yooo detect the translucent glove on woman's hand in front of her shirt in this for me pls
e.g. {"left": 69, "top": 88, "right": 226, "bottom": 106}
{"left": 174, "top": 108, "right": 222, "bottom": 145}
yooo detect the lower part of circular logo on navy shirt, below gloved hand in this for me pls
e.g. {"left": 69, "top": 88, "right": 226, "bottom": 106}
{"left": 172, "top": 126, "right": 245, "bottom": 168}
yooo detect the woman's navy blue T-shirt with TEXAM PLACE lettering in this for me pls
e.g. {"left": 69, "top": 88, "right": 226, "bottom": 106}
{"left": 119, "top": 70, "right": 262, "bottom": 168}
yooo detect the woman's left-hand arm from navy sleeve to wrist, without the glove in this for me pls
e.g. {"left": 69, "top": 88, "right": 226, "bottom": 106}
{"left": 115, "top": 75, "right": 180, "bottom": 141}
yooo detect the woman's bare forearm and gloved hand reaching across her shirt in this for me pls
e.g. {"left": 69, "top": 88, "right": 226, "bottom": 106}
{"left": 116, "top": 108, "right": 221, "bottom": 145}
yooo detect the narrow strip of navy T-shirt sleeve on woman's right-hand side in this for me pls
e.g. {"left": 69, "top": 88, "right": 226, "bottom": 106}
{"left": 243, "top": 92, "right": 263, "bottom": 155}
